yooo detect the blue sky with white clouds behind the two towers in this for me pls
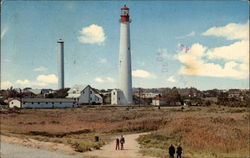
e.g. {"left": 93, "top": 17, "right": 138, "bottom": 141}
{"left": 1, "top": 1, "right": 249, "bottom": 90}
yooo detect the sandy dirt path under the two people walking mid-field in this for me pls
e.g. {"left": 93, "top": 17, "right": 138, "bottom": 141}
{"left": 84, "top": 133, "right": 155, "bottom": 158}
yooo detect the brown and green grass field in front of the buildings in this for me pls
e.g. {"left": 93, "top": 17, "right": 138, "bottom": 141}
{"left": 0, "top": 106, "right": 250, "bottom": 158}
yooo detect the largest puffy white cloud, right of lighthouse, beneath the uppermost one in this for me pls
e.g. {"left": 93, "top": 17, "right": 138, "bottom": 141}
{"left": 175, "top": 43, "right": 249, "bottom": 79}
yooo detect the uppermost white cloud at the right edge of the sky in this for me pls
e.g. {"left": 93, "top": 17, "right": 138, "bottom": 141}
{"left": 202, "top": 21, "right": 249, "bottom": 40}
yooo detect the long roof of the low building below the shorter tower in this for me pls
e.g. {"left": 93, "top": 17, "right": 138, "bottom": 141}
{"left": 22, "top": 98, "right": 75, "bottom": 102}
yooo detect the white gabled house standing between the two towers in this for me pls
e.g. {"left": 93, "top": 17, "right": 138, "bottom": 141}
{"left": 67, "top": 85, "right": 103, "bottom": 104}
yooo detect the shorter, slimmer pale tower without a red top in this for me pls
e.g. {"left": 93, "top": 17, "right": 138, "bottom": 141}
{"left": 57, "top": 39, "right": 64, "bottom": 89}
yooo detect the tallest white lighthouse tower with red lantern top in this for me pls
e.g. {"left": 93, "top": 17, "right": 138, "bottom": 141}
{"left": 119, "top": 5, "right": 133, "bottom": 105}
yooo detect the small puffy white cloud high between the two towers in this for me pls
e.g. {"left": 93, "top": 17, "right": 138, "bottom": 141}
{"left": 78, "top": 24, "right": 106, "bottom": 44}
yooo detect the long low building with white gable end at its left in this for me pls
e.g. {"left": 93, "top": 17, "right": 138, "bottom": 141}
{"left": 9, "top": 98, "right": 78, "bottom": 109}
